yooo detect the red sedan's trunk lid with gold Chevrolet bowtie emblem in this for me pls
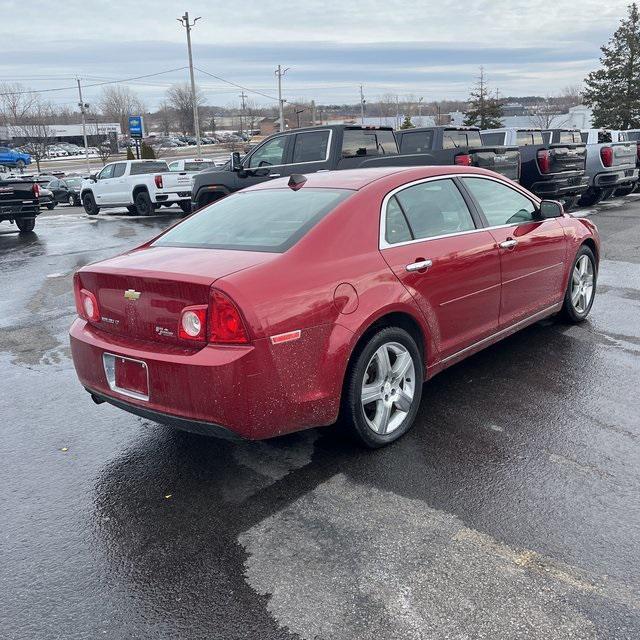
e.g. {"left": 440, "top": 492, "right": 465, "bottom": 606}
{"left": 79, "top": 247, "right": 277, "bottom": 344}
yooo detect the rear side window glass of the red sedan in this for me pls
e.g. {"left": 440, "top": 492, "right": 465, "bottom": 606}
{"left": 385, "top": 179, "right": 476, "bottom": 244}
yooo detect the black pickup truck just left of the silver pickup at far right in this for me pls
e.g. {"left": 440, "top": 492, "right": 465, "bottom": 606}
{"left": 481, "top": 127, "right": 589, "bottom": 211}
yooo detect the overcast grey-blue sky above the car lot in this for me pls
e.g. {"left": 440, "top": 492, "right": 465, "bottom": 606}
{"left": 0, "top": 0, "right": 628, "bottom": 108}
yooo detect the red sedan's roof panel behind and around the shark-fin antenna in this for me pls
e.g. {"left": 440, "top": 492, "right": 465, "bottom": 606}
{"left": 243, "top": 165, "right": 496, "bottom": 191}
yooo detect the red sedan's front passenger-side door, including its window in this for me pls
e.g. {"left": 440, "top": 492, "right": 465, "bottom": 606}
{"left": 461, "top": 176, "right": 566, "bottom": 327}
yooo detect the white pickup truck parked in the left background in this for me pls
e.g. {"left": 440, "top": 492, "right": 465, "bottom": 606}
{"left": 80, "top": 160, "right": 193, "bottom": 216}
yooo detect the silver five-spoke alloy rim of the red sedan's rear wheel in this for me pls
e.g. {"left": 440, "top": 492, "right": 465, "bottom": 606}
{"left": 360, "top": 342, "right": 416, "bottom": 435}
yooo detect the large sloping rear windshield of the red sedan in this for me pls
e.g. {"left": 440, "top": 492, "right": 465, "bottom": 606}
{"left": 153, "top": 188, "right": 353, "bottom": 253}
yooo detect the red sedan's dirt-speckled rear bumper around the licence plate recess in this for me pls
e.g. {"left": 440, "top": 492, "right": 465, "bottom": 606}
{"left": 69, "top": 319, "right": 352, "bottom": 439}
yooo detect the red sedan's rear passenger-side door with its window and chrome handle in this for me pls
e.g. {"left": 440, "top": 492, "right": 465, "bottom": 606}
{"left": 380, "top": 177, "right": 500, "bottom": 359}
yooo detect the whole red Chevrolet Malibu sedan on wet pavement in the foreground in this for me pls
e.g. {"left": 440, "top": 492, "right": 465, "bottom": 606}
{"left": 70, "top": 167, "right": 600, "bottom": 447}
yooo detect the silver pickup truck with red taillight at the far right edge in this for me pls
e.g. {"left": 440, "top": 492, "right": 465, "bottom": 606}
{"left": 549, "top": 129, "right": 638, "bottom": 207}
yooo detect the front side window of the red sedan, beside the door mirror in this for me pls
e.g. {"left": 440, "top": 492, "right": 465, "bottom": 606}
{"left": 462, "top": 178, "right": 536, "bottom": 227}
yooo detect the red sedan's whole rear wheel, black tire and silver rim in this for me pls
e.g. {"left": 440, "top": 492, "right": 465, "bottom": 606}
{"left": 342, "top": 327, "right": 423, "bottom": 449}
